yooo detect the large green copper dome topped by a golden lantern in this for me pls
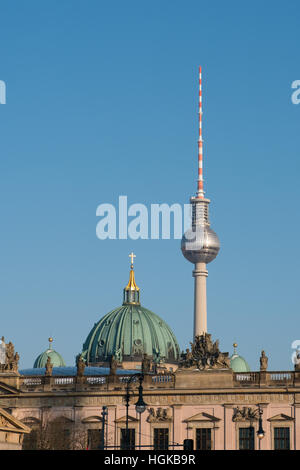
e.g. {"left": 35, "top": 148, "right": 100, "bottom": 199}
{"left": 82, "top": 265, "right": 180, "bottom": 365}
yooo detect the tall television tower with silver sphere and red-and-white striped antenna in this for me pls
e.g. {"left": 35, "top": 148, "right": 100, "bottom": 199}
{"left": 181, "top": 67, "right": 220, "bottom": 338}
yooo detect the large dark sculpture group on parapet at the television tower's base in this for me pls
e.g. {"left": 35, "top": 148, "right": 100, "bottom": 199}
{"left": 180, "top": 333, "right": 230, "bottom": 370}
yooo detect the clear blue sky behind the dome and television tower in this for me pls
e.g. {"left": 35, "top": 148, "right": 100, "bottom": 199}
{"left": 0, "top": 0, "right": 300, "bottom": 370}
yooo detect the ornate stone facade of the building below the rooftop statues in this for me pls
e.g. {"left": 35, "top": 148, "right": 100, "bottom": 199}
{"left": 0, "top": 367, "right": 300, "bottom": 450}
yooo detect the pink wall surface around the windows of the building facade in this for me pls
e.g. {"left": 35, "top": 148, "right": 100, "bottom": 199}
{"left": 13, "top": 402, "right": 300, "bottom": 450}
